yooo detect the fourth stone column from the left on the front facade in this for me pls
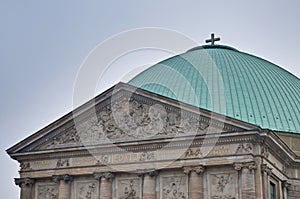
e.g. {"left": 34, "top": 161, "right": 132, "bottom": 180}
{"left": 143, "top": 170, "right": 158, "bottom": 199}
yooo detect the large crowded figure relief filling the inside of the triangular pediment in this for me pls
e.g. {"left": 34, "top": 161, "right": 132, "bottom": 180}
{"left": 42, "top": 98, "right": 216, "bottom": 148}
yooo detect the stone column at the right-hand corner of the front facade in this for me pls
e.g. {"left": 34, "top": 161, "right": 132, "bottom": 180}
{"left": 234, "top": 162, "right": 256, "bottom": 199}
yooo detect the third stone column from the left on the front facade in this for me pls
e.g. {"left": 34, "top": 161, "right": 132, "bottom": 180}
{"left": 99, "top": 172, "right": 115, "bottom": 199}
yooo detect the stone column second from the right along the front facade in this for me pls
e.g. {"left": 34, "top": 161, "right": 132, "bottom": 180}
{"left": 183, "top": 165, "right": 204, "bottom": 199}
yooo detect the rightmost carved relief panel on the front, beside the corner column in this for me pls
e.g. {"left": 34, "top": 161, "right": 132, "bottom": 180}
{"left": 208, "top": 172, "right": 238, "bottom": 199}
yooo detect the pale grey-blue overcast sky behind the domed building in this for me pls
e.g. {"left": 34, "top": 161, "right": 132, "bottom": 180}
{"left": 0, "top": 0, "right": 300, "bottom": 199}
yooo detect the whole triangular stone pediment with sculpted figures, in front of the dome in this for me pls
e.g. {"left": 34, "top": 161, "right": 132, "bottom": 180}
{"left": 8, "top": 83, "right": 258, "bottom": 154}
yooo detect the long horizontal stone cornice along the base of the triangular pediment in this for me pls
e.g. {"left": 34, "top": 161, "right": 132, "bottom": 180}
{"left": 15, "top": 131, "right": 259, "bottom": 161}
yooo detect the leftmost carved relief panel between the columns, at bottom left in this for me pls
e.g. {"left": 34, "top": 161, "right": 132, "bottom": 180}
{"left": 36, "top": 184, "right": 58, "bottom": 199}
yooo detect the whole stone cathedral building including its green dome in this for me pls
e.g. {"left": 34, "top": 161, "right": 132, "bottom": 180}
{"left": 7, "top": 41, "right": 300, "bottom": 199}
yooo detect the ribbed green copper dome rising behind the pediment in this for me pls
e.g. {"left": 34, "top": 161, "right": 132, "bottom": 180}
{"left": 129, "top": 45, "right": 300, "bottom": 133}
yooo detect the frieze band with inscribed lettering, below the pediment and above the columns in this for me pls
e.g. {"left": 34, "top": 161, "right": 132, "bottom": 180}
{"left": 28, "top": 144, "right": 251, "bottom": 170}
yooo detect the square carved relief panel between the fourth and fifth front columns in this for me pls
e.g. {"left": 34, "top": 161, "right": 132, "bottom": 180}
{"left": 160, "top": 175, "right": 188, "bottom": 199}
